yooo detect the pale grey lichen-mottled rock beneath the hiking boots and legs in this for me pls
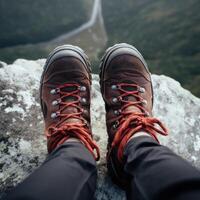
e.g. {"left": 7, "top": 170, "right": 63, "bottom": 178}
{"left": 0, "top": 59, "right": 200, "bottom": 200}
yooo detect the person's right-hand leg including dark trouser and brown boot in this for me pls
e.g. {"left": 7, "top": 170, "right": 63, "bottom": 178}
{"left": 100, "top": 43, "right": 200, "bottom": 200}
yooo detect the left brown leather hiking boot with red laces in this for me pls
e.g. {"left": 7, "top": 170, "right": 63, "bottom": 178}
{"left": 40, "top": 45, "right": 99, "bottom": 160}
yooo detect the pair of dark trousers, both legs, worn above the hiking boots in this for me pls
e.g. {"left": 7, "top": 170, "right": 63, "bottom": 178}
{"left": 3, "top": 136, "right": 200, "bottom": 200}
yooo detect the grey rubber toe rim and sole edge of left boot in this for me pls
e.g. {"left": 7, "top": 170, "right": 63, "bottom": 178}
{"left": 40, "top": 45, "right": 91, "bottom": 113}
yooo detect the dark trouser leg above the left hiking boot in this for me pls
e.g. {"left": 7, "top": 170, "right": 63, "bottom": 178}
{"left": 6, "top": 142, "right": 97, "bottom": 200}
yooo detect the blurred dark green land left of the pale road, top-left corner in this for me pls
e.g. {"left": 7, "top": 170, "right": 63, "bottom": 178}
{"left": 0, "top": 0, "right": 93, "bottom": 48}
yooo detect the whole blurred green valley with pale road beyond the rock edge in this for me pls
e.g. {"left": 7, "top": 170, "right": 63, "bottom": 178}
{"left": 0, "top": 0, "right": 200, "bottom": 97}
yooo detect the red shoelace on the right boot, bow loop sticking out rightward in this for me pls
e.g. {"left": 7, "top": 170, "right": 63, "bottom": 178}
{"left": 111, "top": 83, "right": 168, "bottom": 162}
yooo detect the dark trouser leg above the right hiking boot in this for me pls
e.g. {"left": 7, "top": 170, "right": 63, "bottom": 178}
{"left": 124, "top": 136, "right": 200, "bottom": 200}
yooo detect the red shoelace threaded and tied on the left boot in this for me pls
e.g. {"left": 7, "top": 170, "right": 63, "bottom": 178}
{"left": 45, "top": 83, "right": 100, "bottom": 160}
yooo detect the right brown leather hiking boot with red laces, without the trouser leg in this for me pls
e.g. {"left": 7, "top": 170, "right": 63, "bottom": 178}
{"left": 100, "top": 43, "right": 167, "bottom": 187}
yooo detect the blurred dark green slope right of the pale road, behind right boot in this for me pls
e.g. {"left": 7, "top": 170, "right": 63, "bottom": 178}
{"left": 103, "top": 0, "right": 200, "bottom": 96}
